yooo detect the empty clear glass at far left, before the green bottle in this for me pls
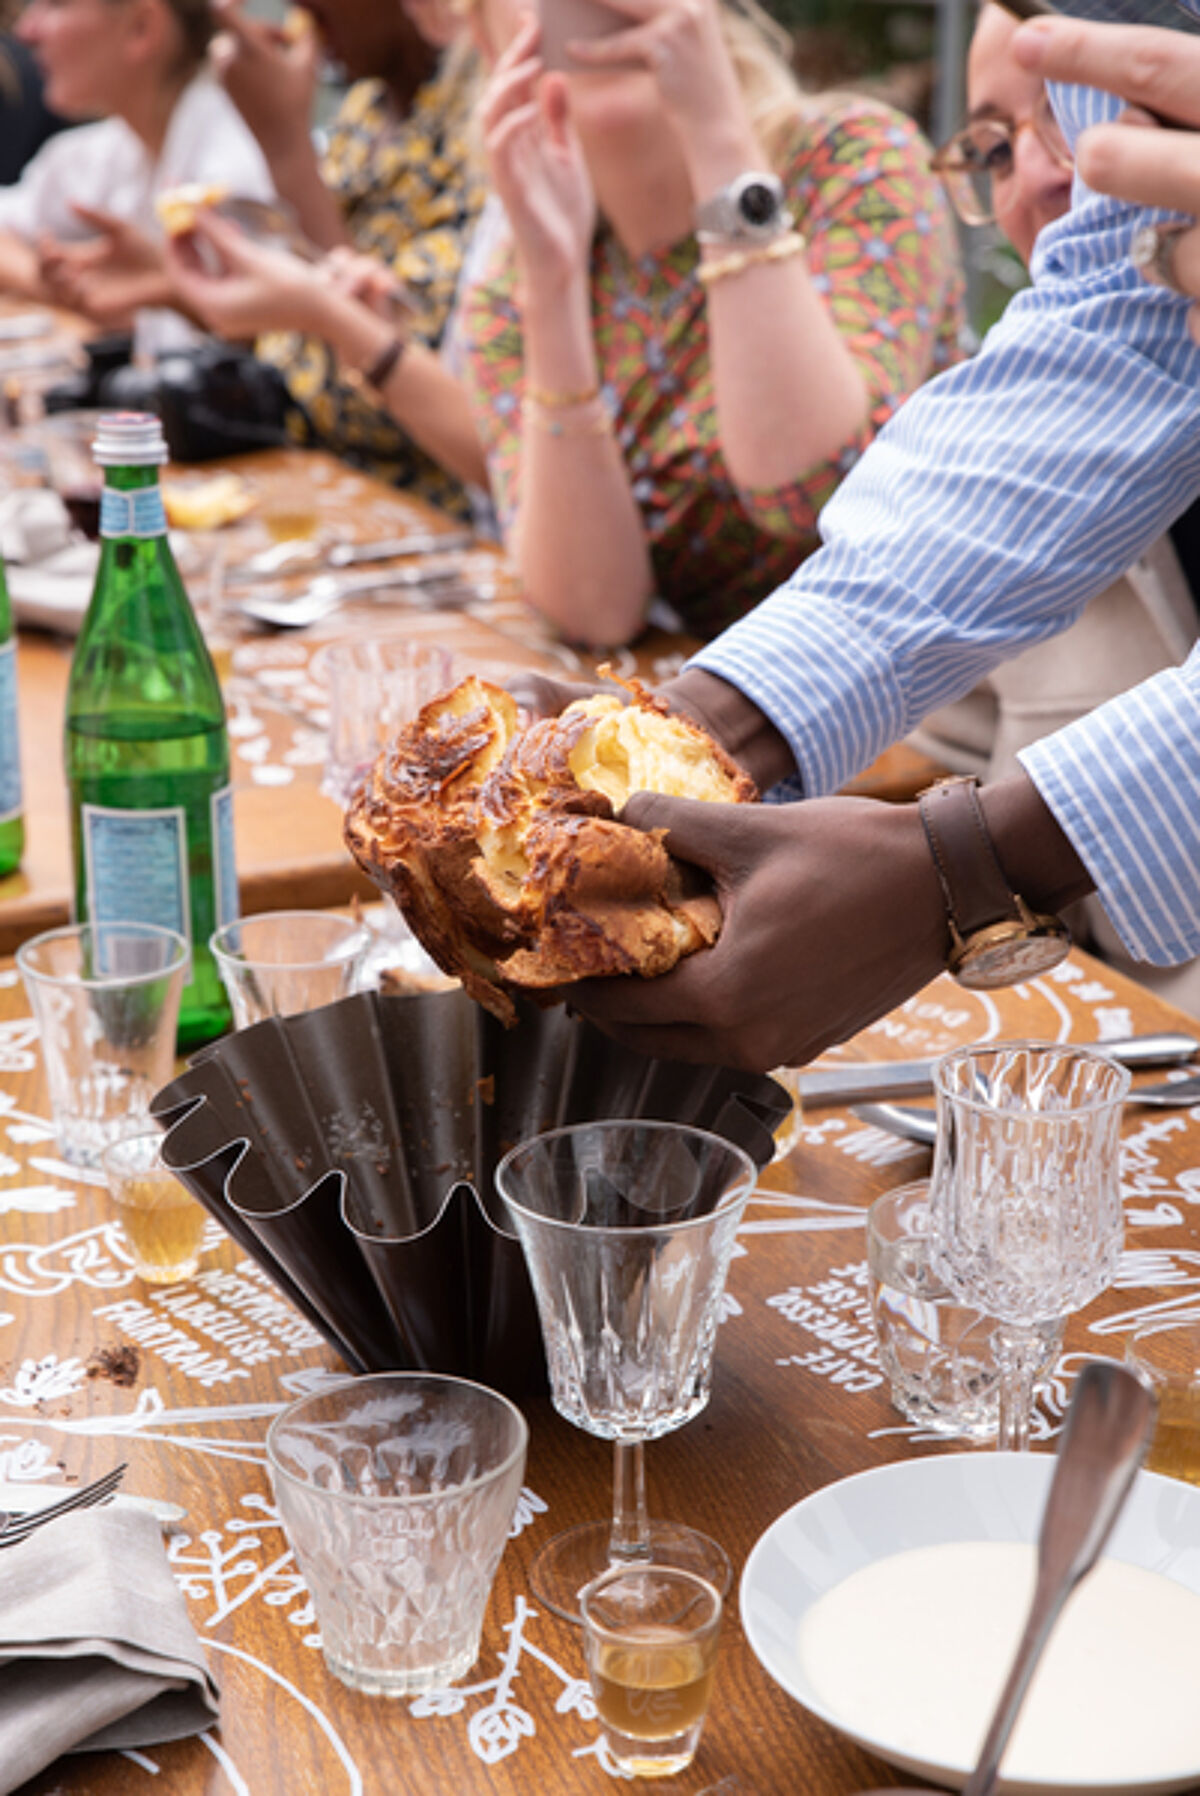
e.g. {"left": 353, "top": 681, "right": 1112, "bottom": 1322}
{"left": 16, "top": 923, "right": 190, "bottom": 1166}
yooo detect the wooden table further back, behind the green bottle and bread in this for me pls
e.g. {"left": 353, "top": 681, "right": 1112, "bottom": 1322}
{"left": 0, "top": 449, "right": 693, "bottom": 954}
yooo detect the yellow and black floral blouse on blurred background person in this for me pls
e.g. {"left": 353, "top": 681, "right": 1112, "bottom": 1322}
{"left": 257, "top": 57, "right": 487, "bottom": 512}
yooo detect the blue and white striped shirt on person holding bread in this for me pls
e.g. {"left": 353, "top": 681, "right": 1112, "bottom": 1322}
{"left": 692, "top": 75, "right": 1200, "bottom": 964}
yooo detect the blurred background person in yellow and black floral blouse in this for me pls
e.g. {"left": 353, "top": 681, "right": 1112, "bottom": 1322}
{"left": 196, "top": 0, "right": 487, "bottom": 512}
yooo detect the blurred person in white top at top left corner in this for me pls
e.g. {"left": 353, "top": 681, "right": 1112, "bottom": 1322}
{"left": 0, "top": 0, "right": 271, "bottom": 356}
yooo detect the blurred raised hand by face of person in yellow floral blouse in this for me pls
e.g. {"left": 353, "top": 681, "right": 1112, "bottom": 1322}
{"left": 212, "top": 0, "right": 320, "bottom": 162}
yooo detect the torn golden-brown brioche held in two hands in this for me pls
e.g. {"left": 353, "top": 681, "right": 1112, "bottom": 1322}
{"left": 345, "top": 677, "right": 758, "bottom": 1022}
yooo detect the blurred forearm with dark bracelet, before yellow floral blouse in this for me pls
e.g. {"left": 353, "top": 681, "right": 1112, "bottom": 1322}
{"left": 323, "top": 295, "right": 487, "bottom": 487}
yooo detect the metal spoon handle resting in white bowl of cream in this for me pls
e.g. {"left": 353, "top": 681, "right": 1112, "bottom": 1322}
{"left": 864, "top": 1360, "right": 1157, "bottom": 1796}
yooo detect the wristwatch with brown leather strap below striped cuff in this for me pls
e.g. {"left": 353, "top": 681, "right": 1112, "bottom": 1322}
{"left": 916, "top": 778, "right": 1071, "bottom": 991}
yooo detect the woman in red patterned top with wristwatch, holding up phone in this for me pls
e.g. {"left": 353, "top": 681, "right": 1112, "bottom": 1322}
{"left": 465, "top": 0, "right": 959, "bottom": 645}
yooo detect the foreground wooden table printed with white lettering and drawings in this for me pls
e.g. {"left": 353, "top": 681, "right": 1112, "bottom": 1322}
{"left": 0, "top": 955, "right": 1200, "bottom": 1796}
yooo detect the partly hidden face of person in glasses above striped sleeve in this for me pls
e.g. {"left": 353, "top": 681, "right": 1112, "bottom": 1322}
{"left": 966, "top": 5, "right": 1071, "bottom": 262}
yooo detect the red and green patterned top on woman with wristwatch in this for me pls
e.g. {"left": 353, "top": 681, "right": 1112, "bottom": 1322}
{"left": 465, "top": 97, "right": 961, "bottom": 636}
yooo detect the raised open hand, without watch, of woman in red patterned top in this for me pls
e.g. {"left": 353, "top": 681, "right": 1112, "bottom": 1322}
{"left": 481, "top": 18, "right": 596, "bottom": 286}
